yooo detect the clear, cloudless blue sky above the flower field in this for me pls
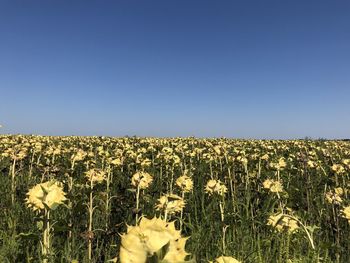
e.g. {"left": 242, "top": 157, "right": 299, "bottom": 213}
{"left": 0, "top": 0, "right": 350, "bottom": 138}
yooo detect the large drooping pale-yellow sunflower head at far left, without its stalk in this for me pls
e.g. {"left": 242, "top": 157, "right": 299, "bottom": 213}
{"left": 26, "top": 181, "right": 66, "bottom": 211}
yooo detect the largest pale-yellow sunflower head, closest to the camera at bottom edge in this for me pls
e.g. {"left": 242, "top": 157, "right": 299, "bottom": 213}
{"left": 119, "top": 217, "right": 189, "bottom": 263}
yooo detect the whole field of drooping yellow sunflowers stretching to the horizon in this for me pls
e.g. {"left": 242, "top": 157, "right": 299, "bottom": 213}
{"left": 0, "top": 135, "right": 350, "bottom": 263}
